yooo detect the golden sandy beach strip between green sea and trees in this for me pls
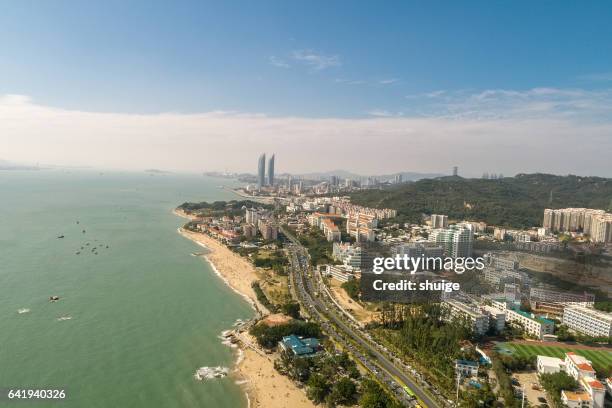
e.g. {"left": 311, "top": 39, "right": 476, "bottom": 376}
{"left": 173, "top": 209, "right": 314, "bottom": 408}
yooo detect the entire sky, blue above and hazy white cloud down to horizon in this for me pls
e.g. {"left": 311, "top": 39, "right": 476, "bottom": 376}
{"left": 0, "top": 0, "right": 612, "bottom": 177}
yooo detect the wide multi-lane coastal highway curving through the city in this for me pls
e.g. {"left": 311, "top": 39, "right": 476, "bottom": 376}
{"left": 282, "top": 229, "right": 443, "bottom": 408}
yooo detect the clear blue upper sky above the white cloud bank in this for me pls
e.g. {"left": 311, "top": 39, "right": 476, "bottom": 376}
{"left": 0, "top": 1, "right": 612, "bottom": 117}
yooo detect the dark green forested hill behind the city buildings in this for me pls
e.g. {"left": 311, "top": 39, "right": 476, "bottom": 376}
{"left": 351, "top": 174, "right": 612, "bottom": 228}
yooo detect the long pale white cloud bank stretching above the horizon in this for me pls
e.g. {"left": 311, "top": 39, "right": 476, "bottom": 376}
{"left": 0, "top": 91, "right": 612, "bottom": 176}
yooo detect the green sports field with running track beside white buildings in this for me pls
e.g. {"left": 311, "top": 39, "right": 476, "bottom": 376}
{"left": 497, "top": 343, "right": 612, "bottom": 371}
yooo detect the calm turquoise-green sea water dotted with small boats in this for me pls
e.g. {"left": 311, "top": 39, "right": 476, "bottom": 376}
{"left": 0, "top": 170, "right": 253, "bottom": 408}
